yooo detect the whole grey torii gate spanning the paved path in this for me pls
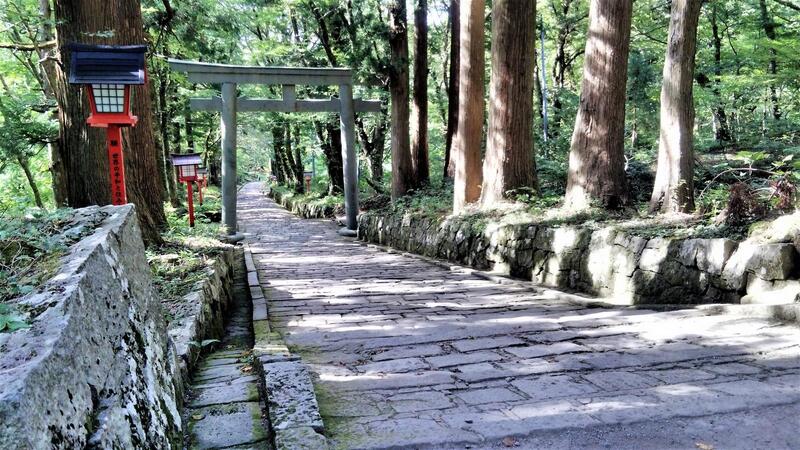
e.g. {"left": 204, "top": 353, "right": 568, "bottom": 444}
{"left": 169, "top": 59, "right": 381, "bottom": 237}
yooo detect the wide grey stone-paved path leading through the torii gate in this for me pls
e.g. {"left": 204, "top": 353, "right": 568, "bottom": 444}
{"left": 240, "top": 184, "right": 800, "bottom": 449}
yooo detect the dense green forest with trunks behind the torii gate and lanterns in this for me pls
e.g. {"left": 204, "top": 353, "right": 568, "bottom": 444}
{"left": 0, "top": 0, "right": 800, "bottom": 239}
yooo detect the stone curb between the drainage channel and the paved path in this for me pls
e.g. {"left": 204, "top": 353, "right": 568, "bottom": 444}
{"left": 244, "top": 248, "right": 330, "bottom": 450}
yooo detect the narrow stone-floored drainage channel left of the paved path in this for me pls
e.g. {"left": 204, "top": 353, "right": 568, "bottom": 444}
{"left": 184, "top": 255, "right": 273, "bottom": 450}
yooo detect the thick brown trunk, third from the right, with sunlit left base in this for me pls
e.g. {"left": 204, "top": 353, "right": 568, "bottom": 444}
{"left": 481, "top": 0, "right": 537, "bottom": 206}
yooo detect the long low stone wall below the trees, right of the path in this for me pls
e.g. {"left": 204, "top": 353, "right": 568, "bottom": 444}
{"left": 358, "top": 212, "right": 800, "bottom": 304}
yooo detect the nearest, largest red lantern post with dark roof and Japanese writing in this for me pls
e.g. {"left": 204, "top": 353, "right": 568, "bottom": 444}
{"left": 69, "top": 44, "right": 147, "bottom": 205}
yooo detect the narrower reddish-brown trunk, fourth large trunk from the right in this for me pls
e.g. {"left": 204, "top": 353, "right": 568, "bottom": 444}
{"left": 451, "top": 0, "right": 486, "bottom": 213}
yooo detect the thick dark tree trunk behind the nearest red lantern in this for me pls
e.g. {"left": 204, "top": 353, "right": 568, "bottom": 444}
{"left": 55, "top": 0, "right": 166, "bottom": 243}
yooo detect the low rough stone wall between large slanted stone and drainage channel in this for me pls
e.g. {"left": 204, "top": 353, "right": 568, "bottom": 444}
{"left": 167, "top": 246, "right": 236, "bottom": 399}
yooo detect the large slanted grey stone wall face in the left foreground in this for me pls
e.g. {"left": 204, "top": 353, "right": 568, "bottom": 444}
{"left": 0, "top": 205, "right": 182, "bottom": 449}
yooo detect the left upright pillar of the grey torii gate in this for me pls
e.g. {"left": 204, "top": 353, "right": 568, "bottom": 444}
{"left": 220, "top": 83, "right": 237, "bottom": 236}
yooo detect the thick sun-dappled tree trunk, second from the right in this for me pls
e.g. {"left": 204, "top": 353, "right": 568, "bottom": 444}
{"left": 565, "top": 0, "right": 633, "bottom": 209}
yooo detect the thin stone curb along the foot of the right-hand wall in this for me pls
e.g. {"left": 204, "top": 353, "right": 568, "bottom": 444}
{"left": 355, "top": 240, "right": 800, "bottom": 324}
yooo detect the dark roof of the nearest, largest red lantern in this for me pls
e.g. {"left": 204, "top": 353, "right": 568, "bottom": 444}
{"left": 69, "top": 44, "right": 147, "bottom": 84}
